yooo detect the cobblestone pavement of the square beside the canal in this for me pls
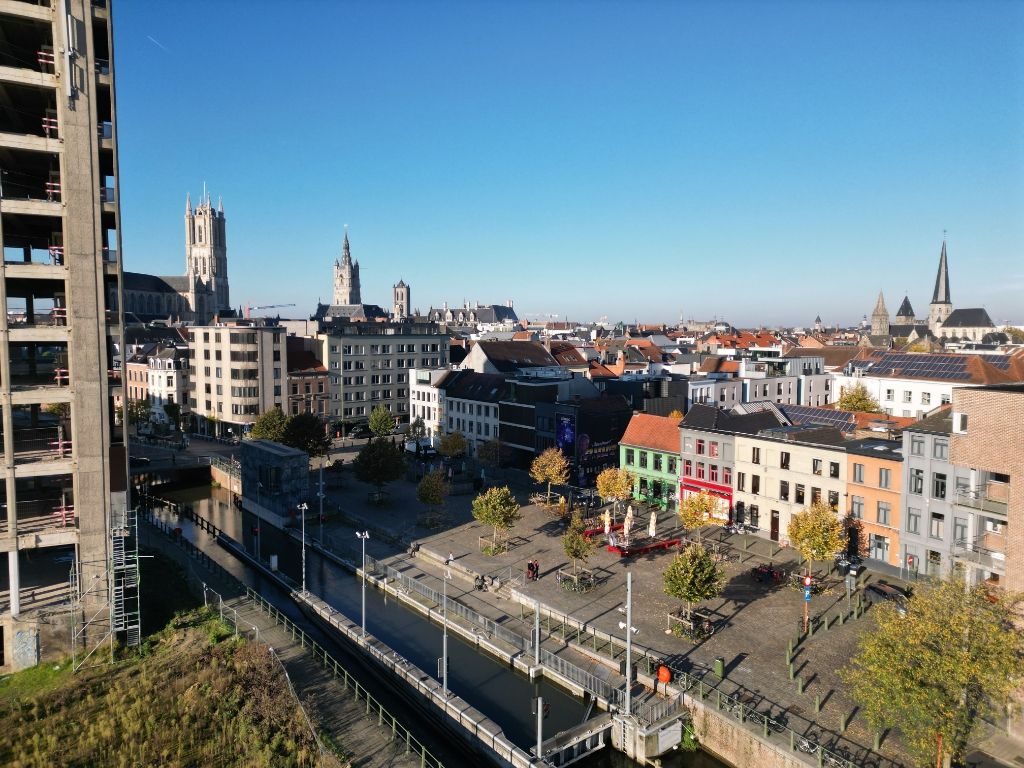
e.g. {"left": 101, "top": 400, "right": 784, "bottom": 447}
{"left": 313, "top": 462, "right": 1020, "bottom": 765}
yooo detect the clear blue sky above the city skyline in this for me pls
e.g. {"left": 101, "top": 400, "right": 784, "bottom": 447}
{"left": 115, "top": 0, "right": 1024, "bottom": 326}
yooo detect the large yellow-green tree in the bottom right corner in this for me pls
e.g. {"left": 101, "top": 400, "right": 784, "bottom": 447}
{"left": 841, "top": 575, "right": 1024, "bottom": 765}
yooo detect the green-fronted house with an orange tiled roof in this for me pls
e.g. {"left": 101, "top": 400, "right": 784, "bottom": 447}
{"left": 618, "top": 414, "right": 680, "bottom": 510}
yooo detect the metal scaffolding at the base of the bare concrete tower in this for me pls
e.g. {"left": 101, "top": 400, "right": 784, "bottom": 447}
{"left": 71, "top": 509, "right": 142, "bottom": 670}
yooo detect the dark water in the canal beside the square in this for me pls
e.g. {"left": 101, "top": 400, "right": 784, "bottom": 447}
{"left": 155, "top": 486, "right": 725, "bottom": 768}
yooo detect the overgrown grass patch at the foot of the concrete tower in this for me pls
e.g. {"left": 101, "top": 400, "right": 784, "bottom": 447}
{"left": 0, "top": 609, "right": 338, "bottom": 768}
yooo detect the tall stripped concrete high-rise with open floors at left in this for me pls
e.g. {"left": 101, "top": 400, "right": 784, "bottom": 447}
{"left": 0, "top": 0, "right": 130, "bottom": 673}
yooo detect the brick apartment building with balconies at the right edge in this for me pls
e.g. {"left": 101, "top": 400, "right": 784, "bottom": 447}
{"left": 950, "top": 383, "right": 1024, "bottom": 593}
